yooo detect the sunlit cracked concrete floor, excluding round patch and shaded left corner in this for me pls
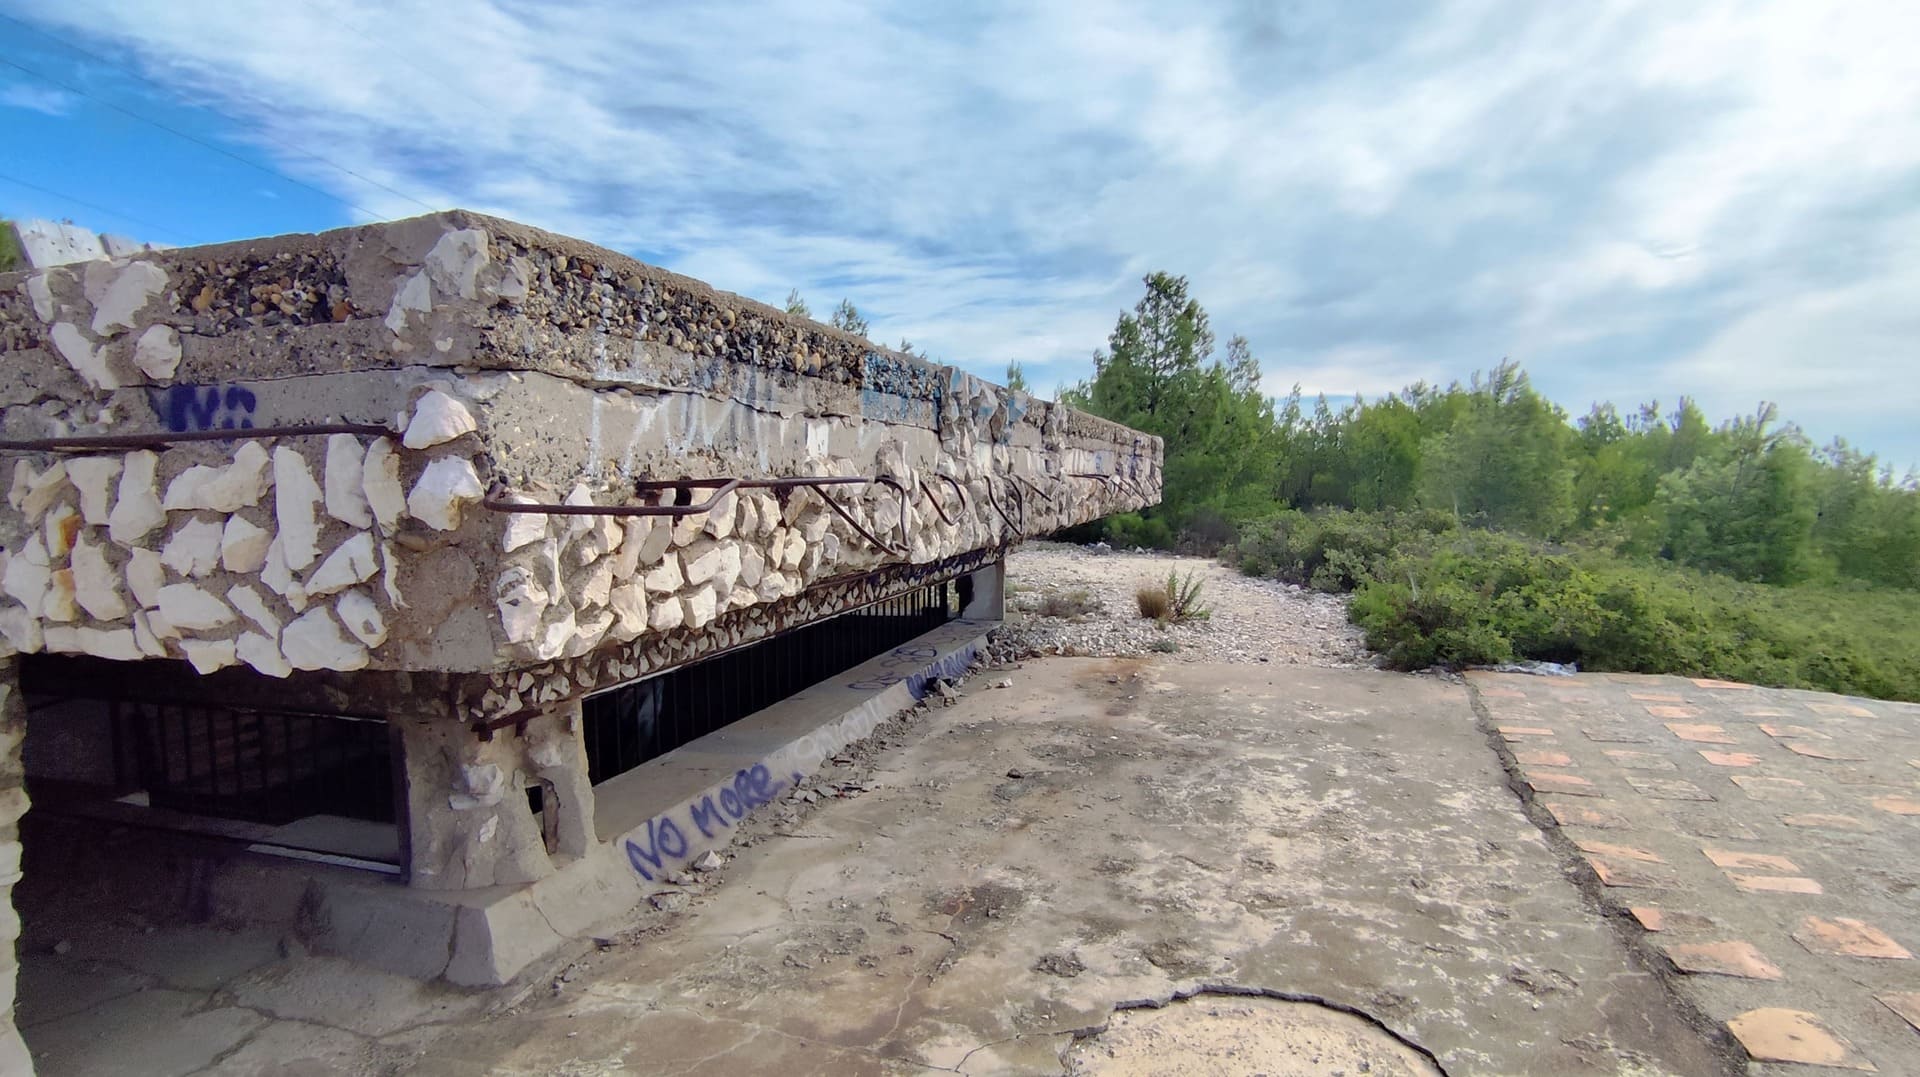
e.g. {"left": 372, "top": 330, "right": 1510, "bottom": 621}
{"left": 409, "top": 658, "right": 1736, "bottom": 1075}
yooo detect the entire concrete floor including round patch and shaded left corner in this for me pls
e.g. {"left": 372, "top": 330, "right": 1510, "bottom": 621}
{"left": 21, "top": 658, "right": 1812, "bottom": 1077}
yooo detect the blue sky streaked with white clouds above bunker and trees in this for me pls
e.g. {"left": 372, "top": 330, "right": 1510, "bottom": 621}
{"left": 0, "top": 0, "right": 1920, "bottom": 470}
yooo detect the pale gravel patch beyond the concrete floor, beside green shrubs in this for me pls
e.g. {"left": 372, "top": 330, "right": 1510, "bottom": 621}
{"left": 996, "top": 541, "right": 1375, "bottom": 668}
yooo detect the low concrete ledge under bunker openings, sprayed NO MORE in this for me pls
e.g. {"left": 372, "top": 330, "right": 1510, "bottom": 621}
{"left": 313, "top": 620, "right": 1000, "bottom": 987}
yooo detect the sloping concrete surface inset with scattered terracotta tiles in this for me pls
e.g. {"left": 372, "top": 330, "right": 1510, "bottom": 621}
{"left": 1467, "top": 672, "right": 1920, "bottom": 1073}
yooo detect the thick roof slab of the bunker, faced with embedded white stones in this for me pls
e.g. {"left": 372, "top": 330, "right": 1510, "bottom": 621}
{"left": 0, "top": 213, "right": 1160, "bottom": 710}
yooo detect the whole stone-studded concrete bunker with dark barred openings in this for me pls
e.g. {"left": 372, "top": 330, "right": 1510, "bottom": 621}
{"left": 0, "top": 211, "right": 1162, "bottom": 1062}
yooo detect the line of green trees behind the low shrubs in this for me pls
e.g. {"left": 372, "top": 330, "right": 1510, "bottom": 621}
{"left": 1060, "top": 273, "right": 1920, "bottom": 589}
